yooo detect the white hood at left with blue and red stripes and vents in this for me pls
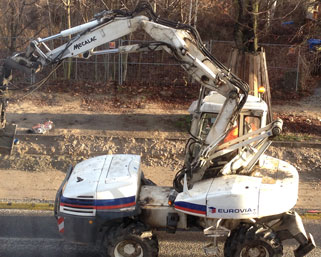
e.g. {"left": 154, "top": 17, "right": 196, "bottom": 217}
{"left": 59, "top": 154, "right": 141, "bottom": 216}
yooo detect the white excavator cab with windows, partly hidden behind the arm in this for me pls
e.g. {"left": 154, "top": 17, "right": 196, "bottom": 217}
{"left": 185, "top": 91, "right": 268, "bottom": 165}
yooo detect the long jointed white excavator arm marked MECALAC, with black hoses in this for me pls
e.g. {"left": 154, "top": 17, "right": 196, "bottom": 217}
{"left": 0, "top": 2, "right": 249, "bottom": 177}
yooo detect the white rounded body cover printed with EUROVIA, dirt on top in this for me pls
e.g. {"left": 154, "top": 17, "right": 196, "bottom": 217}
{"left": 175, "top": 156, "right": 299, "bottom": 219}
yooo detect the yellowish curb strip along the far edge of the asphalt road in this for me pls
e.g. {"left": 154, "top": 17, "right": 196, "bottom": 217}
{"left": 0, "top": 201, "right": 321, "bottom": 220}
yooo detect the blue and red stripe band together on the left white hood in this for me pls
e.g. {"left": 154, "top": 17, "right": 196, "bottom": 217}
{"left": 60, "top": 196, "right": 136, "bottom": 210}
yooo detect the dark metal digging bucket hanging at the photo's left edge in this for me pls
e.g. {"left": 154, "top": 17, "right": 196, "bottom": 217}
{"left": 0, "top": 124, "right": 17, "bottom": 155}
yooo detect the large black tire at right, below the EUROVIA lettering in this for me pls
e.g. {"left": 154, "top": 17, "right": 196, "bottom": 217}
{"left": 224, "top": 224, "right": 283, "bottom": 257}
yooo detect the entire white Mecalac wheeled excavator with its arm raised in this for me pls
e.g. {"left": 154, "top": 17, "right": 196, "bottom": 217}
{"left": 0, "top": 1, "right": 315, "bottom": 257}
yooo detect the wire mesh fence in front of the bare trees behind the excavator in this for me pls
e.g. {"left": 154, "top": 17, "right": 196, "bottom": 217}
{"left": 1, "top": 39, "right": 314, "bottom": 90}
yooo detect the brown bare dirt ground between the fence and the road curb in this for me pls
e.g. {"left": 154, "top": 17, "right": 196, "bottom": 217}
{"left": 0, "top": 81, "right": 321, "bottom": 209}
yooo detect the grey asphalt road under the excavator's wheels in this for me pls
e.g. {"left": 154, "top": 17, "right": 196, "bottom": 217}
{"left": 0, "top": 210, "right": 321, "bottom": 257}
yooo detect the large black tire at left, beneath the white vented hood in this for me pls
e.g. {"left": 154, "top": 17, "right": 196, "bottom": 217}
{"left": 105, "top": 223, "right": 158, "bottom": 257}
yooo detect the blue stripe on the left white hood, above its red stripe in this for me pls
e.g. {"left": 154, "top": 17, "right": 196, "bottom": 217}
{"left": 60, "top": 196, "right": 135, "bottom": 206}
